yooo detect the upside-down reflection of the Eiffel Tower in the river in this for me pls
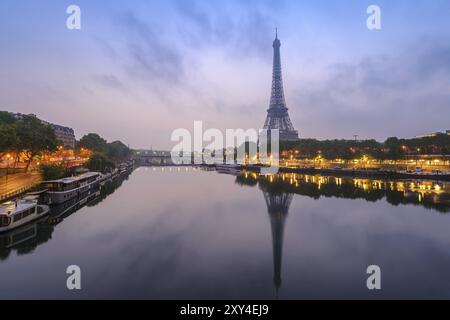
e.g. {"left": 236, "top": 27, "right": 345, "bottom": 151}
{"left": 262, "top": 188, "right": 293, "bottom": 295}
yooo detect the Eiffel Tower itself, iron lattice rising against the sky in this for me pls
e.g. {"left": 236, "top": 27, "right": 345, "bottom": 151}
{"left": 264, "top": 30, "right": 299, "bottom": 141}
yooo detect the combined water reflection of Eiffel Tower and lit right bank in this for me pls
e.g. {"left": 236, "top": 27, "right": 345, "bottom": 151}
{"left": 235, "top": 172, "right": 450, "bottom": 297}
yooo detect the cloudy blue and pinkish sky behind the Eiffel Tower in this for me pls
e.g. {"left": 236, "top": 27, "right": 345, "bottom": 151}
{"left": 0, "top": 0, "right": 450, "bottom": 149}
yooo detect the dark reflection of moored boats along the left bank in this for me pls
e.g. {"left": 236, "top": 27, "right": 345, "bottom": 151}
{"left": 0, "top": 173, "right": 130, "bottom": 260}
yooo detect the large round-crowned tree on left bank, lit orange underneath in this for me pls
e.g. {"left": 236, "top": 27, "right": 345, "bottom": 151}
{"left": 15, "top": 116, "right": 58, "bottom": 172}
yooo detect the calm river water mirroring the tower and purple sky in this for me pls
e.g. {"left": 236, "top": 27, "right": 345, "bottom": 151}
{"left": 0, "top": 168, "right": 450, "bottom": 299}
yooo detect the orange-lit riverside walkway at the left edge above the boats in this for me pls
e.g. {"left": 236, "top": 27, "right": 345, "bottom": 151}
{"left": 0, "top": 172, "right": 41, "bottom": 201}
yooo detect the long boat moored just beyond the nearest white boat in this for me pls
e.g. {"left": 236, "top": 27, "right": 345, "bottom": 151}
{"left": 42, "top": 172, "right": 103, "bottom": 204}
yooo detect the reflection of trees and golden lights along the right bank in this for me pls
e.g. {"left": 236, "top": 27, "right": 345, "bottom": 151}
{"left": 236, "top": 173, "right": 450, "bottom": 213}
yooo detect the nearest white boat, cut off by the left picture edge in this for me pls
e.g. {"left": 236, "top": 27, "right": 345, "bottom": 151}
{"left": 0, "top": 196, "right": 50, "bottom": 232}
